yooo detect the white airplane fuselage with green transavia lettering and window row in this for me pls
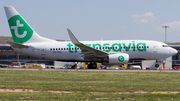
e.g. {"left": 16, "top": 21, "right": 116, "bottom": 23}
{"left": 12, "top": 40, "right": 177, "bottom": 62}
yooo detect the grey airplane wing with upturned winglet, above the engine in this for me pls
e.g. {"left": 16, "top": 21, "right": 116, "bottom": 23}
{"left": 67, "top": 29, "right": 108, "bottom": 59}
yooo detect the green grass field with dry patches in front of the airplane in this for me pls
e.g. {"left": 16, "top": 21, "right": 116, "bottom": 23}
{"left": 0, "top": 70, "right": 180, "bottom": 101}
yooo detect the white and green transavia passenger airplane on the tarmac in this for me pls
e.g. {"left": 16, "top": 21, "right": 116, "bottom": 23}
{"left": 4, "top": 6, "right": 177, "bottom": 69}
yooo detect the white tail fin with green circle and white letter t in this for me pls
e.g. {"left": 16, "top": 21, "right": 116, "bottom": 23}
{"left": 4, "top": 6, "right": 54, "bottom": 43}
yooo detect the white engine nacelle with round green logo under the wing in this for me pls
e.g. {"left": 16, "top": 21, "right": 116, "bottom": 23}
{"left": 103, "top": 53, "right": 129, "bottom": 65}
